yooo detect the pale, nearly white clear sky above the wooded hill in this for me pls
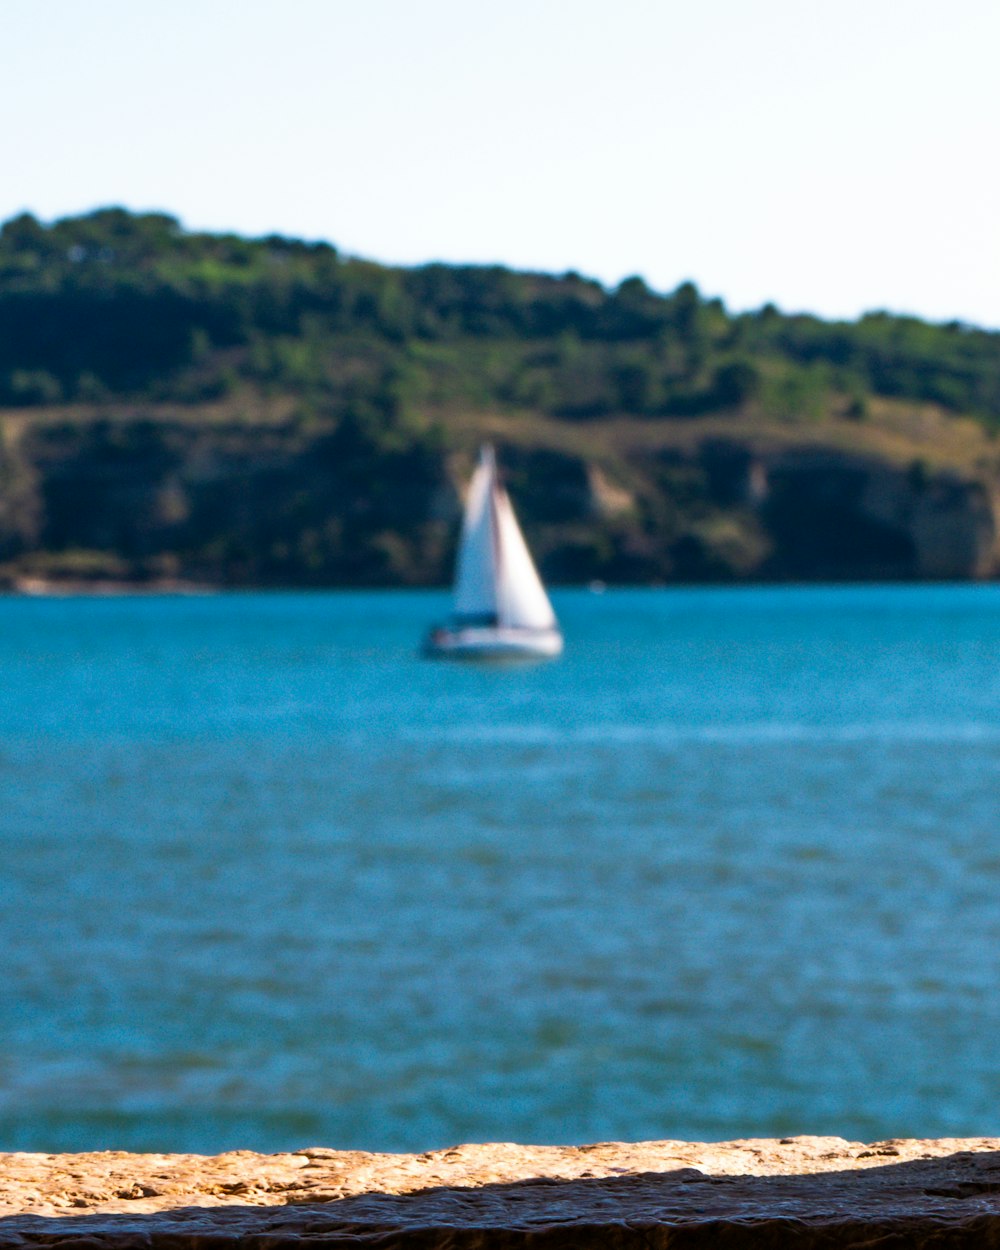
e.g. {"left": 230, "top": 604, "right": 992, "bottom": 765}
{"left": 7, "top": 0, "right": 1000, "bottom": 328}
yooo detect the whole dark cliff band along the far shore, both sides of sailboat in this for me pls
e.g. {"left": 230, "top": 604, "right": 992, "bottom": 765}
{"left": 0, "top": 415, "right": 1000, "bottom": 585}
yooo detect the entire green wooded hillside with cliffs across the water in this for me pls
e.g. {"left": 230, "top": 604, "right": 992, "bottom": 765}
{"left": 0, "top": 209, "right": 1000, "bottom": 586}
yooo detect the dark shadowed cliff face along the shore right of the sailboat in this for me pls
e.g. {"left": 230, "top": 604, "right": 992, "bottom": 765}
{"left": 513, "top": 439, "right": 1000, "bottom": 581}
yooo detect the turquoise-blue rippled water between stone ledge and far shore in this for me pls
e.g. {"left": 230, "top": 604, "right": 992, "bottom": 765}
{"left": 0, "top": 586, "right": 1000, "bottom": 1150}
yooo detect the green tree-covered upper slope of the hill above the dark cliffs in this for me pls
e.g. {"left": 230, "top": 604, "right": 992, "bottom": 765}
{"left": 0, "top": 209, "right": 1000, "bottom": 423}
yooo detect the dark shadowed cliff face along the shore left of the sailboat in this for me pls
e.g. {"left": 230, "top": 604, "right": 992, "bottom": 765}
{"left": 0, "top": 420, "right": 459, "bottom": 585}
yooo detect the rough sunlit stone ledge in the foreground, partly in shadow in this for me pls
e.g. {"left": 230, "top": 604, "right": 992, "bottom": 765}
{"left": 0, "top": 1138, "right": 1000, "bottom": 1250}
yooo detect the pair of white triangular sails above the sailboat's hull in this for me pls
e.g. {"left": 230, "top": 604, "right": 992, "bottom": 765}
{"left": 455, "top": 446, "right": 556, "bottom": 629}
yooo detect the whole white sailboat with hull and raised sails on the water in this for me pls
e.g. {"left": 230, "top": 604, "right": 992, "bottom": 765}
{"left": 424, "top": 445, "right": 563, "bottom": 660}
